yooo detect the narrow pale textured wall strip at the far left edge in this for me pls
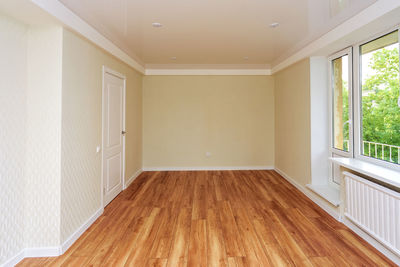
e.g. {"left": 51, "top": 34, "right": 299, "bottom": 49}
{"left": 0, "top": 16, "right": 27, "bottom": 265}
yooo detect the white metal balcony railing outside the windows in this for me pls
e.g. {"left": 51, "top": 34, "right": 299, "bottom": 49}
{"left": 343, "top": 140, "right": 400, "bottom": 164}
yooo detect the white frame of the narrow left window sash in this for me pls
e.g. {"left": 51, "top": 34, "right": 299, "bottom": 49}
{"left": 328, "top": 47, "right": 353, "bottom": 158}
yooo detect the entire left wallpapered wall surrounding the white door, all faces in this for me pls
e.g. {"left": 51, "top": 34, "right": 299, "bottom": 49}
{"left": 0, "top": 16, "right": 142, "bottom": 265}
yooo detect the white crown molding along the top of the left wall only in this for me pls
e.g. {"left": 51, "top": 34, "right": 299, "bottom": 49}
{"left": 31, "top": 0, "right": 145, "bottom": 74}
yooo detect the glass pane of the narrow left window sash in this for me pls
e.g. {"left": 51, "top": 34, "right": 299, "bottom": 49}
{"left": 332, "top": 55, "right": 350, "bottom": 151}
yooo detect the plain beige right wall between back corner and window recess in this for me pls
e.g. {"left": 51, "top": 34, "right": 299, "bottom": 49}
{"left": 274, "top": 59, "right": 311, "bottom": 186}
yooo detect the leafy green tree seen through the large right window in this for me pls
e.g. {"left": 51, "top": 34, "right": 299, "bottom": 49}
{"left": 362, "top": 48, "right": 400, "bottom": 162}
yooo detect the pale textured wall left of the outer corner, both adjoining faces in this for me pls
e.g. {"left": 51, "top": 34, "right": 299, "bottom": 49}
{"left": 0, "top": 16, "right": 62, "bottom": 265}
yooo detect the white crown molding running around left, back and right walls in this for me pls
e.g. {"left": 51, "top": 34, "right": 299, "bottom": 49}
{"left": 30, "top": 0, "right": 400, "bottom": 75}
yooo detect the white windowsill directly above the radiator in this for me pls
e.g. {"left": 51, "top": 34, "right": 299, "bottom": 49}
{"left": 330, "top": 158, "right": 400, "bottom": 188}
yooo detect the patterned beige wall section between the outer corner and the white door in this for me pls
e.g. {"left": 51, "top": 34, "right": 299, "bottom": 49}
{"left": 61, "top": 30, "right": 102, "bottom": 242}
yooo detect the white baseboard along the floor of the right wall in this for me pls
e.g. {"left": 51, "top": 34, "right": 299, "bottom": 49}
{"left": 275, "top": 167, "right": 400, "bottom": 266}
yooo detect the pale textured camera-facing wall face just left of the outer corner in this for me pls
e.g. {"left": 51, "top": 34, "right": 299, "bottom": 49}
{"left": 25, "top": 27, "right": 62, "bottom": 247}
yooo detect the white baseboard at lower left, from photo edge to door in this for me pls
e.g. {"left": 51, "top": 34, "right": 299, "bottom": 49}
{"left": 1, "top": 208, "right": 104, "bottom": 267}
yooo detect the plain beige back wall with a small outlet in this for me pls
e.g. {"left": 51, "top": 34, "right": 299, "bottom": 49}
{"left": 143, "top": 76, "right": 274, "bottom": 168}
